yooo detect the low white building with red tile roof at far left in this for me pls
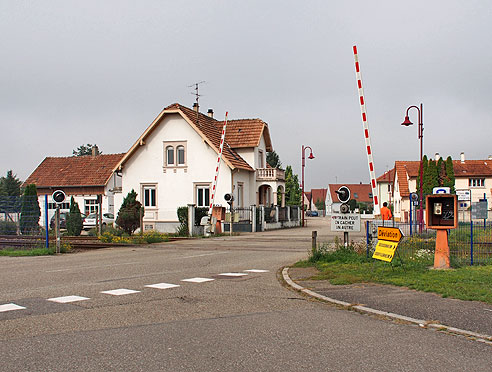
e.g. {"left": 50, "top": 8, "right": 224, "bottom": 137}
{"left": 24, "top": 149, "right": 124, "bottom": 226}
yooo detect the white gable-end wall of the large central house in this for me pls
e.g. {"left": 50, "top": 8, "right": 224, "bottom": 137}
{"left": 115, "top": 114, "right": 247, "bottom": 230}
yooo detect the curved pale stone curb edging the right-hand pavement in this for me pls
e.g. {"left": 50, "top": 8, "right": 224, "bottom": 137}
{"left": 282, "top": 267, "right": 492, "bottom": 345}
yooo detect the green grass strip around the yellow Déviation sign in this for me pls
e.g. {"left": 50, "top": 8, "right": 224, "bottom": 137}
{"left": 296, "top": 247, "right": 492, "bottom": 303}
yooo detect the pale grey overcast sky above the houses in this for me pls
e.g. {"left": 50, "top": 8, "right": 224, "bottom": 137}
{"left": 0, "top": 0, "right": 492, "bottom": 189}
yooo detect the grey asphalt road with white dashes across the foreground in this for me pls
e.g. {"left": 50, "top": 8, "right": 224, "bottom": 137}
{"left": 0, "top": 219, "right": 492, "bottom": 371}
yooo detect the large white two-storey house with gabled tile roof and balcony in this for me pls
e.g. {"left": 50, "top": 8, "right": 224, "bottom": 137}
{"left": 114, "top": 103, "right": 285, "bottom": 232}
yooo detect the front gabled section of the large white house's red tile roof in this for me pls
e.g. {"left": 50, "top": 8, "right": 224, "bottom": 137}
{"left": 117, "top": 103, "right": 253, "bottom": 171}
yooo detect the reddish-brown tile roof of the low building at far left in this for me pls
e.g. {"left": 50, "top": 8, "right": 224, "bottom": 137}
{"left": 24, "top": 154, "right": 125, "bottom": 188}
